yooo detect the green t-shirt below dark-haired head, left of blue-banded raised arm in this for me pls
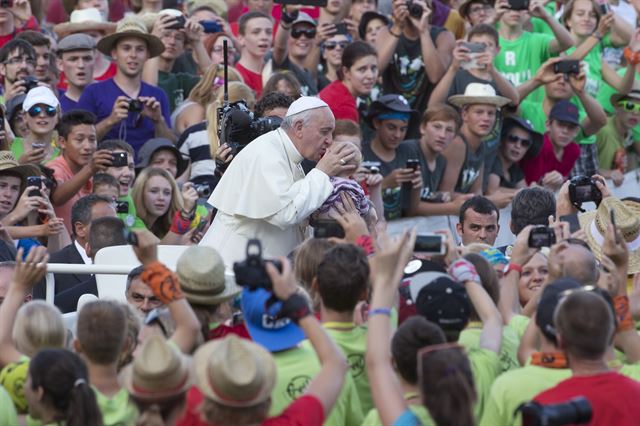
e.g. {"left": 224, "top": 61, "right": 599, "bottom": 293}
{"left": 322, "top": 322, "right": 373, "bottom": 413}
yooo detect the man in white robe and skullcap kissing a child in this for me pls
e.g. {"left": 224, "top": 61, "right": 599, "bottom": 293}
{"left": 200, "top": 97, "right": 354, "bottom": 267}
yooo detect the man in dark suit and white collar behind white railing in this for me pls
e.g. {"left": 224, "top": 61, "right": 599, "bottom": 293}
{"left": 33, "top": 194, "right": 116, "bottom": 298}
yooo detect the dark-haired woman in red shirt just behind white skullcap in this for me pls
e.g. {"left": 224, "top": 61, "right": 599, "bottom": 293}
{"left": 318, "top": 41, "right": 378, "bottom": 123}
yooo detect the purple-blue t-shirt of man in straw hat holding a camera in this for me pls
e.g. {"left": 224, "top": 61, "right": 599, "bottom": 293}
{"left": 77, "top": 78, "right": 171, "bottom": 154}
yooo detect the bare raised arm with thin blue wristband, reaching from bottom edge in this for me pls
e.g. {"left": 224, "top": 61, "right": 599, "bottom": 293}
{"left": 366, "top": 231, "right": 415, "bottom": 426}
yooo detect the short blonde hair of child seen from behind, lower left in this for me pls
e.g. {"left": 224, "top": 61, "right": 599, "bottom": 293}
{"left": 12, "top": 300, "right": 67, "bottom": 358}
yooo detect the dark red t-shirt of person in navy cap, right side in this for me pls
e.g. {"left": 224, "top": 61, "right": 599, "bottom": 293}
{"left": 520, "top": 132, "right": 580, "bottom": 184}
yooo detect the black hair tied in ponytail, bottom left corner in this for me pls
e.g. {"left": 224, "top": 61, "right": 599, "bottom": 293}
{"left": 29, "top": 349, "right": 103, "bottom": 426}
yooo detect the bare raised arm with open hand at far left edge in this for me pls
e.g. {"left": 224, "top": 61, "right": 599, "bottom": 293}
{"left": 0, "top": 246, "right": 49, "bottom": 367}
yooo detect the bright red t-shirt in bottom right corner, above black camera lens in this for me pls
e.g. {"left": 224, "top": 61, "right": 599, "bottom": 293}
{"left": 535, "top": 372, "right": 640, "bottom": 426}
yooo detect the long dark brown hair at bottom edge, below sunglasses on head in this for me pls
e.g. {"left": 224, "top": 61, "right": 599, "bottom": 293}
{"left": 418, "top": 344, "right": 477, "bottom": 426}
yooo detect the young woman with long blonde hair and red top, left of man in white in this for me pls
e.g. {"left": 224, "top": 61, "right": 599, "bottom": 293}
{"left": 131, "top": 167, "right": 201, "bottom": 244}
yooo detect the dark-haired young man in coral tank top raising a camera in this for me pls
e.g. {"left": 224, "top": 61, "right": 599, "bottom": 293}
{"left": 47, "top": 110, "right": 112, "bottom": 233}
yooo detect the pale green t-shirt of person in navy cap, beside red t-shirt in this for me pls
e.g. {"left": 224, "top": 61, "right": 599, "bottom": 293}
{"left": 480, "top": 365, "right": 571, "bottom": 426}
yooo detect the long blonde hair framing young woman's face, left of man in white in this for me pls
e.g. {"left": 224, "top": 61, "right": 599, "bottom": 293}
{"left": 131, "top": 167, "right": 183, "bottom": 238}
